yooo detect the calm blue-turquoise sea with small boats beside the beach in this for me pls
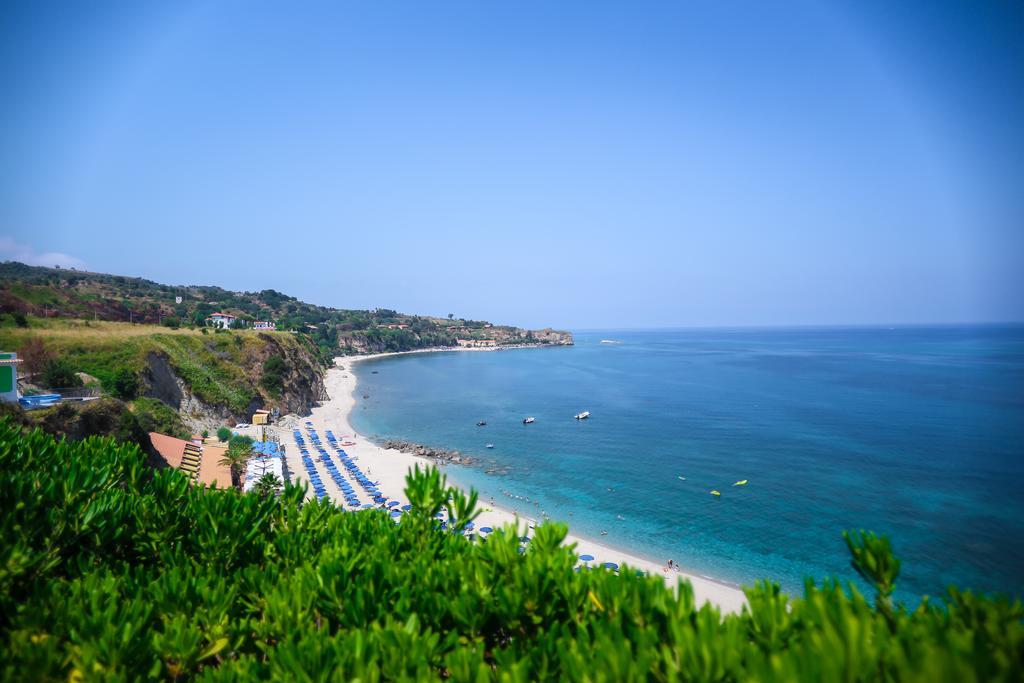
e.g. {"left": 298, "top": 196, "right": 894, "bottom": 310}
{"left": 352, "top": 327, "right": 1024, "bottom": 601}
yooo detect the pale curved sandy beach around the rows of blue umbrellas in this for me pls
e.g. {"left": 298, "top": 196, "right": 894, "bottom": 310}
{"left": 273, "top": 354, "right": 745, "bottom": 612}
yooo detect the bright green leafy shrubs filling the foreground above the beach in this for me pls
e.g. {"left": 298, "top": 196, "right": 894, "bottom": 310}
{"left": 0, "top": 421, "right": 1024, "bottom": 681}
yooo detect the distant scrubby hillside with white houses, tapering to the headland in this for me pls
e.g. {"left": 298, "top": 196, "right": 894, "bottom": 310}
{"left": 0, "top": 261, "right": 571, "bottom": 358}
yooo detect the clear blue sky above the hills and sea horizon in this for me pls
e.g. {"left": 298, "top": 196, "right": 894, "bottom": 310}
{"left": 0, "top": 0, "right": 1024, "bottom": 328}
